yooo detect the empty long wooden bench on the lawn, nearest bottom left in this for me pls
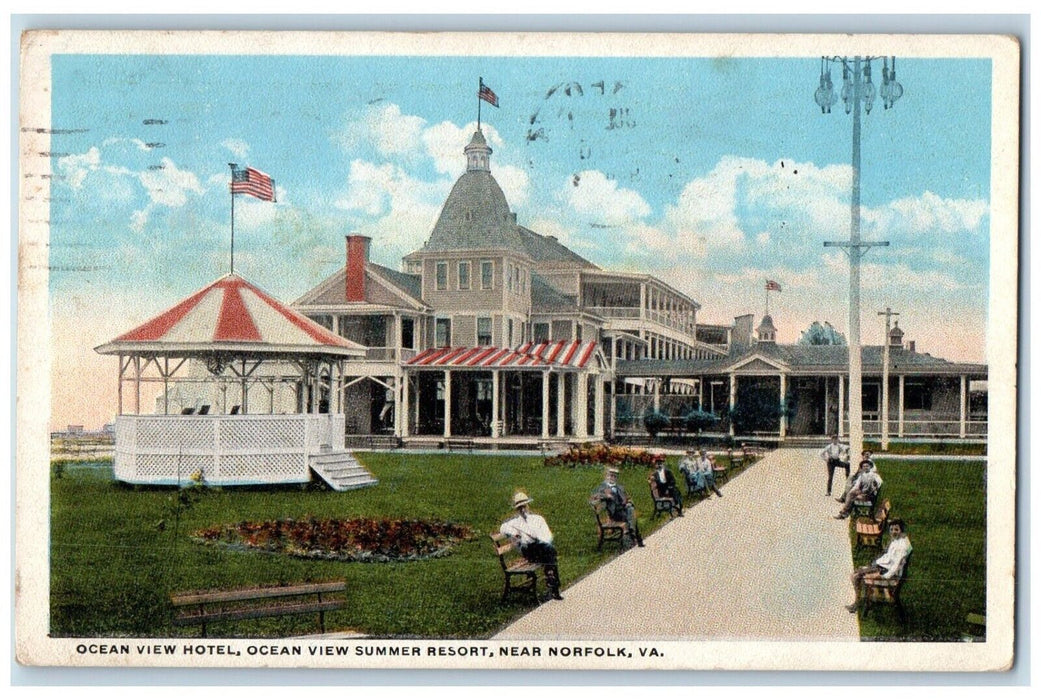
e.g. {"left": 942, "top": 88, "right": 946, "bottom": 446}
{"left": 170, "top": 581, "right": 347, "bottom": 636}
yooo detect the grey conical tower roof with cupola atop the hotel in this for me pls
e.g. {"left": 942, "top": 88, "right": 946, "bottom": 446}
{"left": 423, "top": 131, "right": 527, "bottom": 254}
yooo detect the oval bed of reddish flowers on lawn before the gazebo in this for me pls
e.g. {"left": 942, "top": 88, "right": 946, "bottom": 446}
{"left": 193, "top": 518, "right": 474, "bottom": 561}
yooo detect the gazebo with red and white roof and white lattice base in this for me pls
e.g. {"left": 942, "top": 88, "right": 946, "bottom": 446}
{"left": 95, "top": 273, "right": 365, "bottom": 485}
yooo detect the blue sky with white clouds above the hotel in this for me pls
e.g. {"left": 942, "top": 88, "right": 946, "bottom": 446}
{"left": 50, "top": 55, "right": 991, "bottom": 429}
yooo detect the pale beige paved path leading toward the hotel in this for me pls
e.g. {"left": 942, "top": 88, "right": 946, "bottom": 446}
{"left": 497, "top": 449, "right": 860, "bottom": 642}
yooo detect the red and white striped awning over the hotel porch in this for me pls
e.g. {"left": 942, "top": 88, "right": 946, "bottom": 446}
{"left": 405, "top": 341, "right": 596, "bottom": 370}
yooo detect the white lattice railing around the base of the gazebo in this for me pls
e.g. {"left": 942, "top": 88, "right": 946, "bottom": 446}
{"left": 115, "top": 414, "right": 345, "bottom": 485}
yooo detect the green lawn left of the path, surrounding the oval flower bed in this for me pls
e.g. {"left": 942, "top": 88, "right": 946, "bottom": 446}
{"left": 51, "top": 454, "right": 749, "bottom": 639}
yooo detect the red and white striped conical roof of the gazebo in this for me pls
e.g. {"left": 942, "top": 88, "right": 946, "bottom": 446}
{"left": 95, "top": 274, "right": 365, "bottom": 356}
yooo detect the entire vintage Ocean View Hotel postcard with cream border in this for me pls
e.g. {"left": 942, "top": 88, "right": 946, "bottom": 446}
{"left": 16, "top": 31, "right": 1020, "bottom": 671}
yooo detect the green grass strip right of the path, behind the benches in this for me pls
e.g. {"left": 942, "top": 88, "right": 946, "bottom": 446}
{"left": 850, "top": 459, "right": 982, "bottom": 642}
